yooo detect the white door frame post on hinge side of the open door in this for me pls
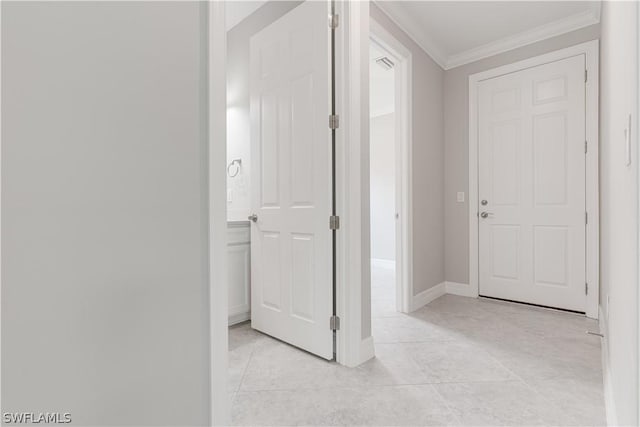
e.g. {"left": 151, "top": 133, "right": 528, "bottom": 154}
{"left": 335, "top": 1, "right": 371, "bottom": 366}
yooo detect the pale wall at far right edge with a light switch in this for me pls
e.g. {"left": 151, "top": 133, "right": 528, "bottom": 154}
{"left": 600, "top": 2, "right": 640, "bottom": 425}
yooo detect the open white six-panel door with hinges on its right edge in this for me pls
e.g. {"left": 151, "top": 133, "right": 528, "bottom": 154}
{"left": 250, "top": 1, "right": 333, "bottom": 359}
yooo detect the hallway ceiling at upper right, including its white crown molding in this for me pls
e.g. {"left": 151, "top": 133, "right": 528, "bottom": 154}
{"left": 376, "top": 0, "right": 600, "bottom": 69}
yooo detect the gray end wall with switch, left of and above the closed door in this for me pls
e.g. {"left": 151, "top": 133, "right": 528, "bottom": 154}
{"left": 444, "top": 25, "right": 600, "bottom": 283}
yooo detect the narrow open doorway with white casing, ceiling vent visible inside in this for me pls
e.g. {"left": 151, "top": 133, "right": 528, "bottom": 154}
{"left": 369, "top": 20, "right": 413, "bottom": 317}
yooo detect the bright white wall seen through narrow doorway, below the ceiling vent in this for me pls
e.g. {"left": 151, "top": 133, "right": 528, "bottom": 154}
{"left": 369, "top": 113, "right": 396, "bottom": 261}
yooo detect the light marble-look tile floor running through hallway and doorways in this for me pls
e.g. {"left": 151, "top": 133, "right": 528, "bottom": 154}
{"left": 229, "top": 269, "right": 605, "bottom": 426}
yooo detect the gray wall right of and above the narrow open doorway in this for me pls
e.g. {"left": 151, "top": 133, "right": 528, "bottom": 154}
{"left": 371, "top": 4, "right": 445, "bottom": 294}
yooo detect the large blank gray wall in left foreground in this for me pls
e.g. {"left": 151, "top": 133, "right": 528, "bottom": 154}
{"left": 2, "top": 2, "right": 210, "bottom": 425}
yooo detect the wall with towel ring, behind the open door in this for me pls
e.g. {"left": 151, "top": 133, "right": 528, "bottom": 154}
{"left": 227, "top": 1, "right": 300, "bottom": 221}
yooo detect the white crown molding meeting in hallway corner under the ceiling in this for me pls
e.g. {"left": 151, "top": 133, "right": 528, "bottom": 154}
{"left": 374, "top": 0, "right": 601, "bottom": 70}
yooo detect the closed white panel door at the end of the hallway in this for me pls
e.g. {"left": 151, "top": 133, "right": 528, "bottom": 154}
{"left": 477, "top": 55, "right": 586, "bottom": 312}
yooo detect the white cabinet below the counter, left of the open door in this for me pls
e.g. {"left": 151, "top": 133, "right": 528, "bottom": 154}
{"left": 227, "top": 221, "right": 251, "bottom": 325}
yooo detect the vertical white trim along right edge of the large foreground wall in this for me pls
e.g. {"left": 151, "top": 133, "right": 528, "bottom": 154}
{"left": 209, "top": 2, "right": 231, "bottom": 425}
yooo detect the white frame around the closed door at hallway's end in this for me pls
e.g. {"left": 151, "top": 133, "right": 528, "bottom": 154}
{"left": 469, "top": 40, "right": 600, "bottom": 319}
